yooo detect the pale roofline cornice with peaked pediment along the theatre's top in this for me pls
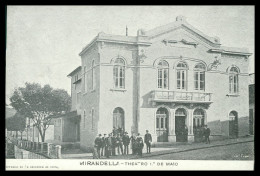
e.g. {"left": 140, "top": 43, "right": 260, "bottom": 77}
{"left": 79, "top": 16, "right": 251, "bottom": 56}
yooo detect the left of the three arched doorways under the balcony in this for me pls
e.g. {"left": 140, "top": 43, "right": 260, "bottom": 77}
{"left": 156, "top": 108, "right": 169, "bottom": 142}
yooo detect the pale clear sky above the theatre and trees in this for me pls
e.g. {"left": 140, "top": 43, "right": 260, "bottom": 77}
{"left": 6, "top": 6, "right": 255, "bottom": 103}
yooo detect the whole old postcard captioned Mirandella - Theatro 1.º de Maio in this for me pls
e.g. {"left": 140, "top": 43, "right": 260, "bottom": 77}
{"left": 5, "top": 5, "right": 255, "bottom": 170}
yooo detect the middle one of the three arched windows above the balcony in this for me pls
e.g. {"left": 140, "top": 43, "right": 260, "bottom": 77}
{"left": 176, "top": 62, "right": 188, "bottom": 90}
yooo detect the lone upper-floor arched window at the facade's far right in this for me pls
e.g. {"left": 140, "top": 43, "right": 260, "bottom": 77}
{"left": 229, "top": 67, "right": 239, "bottom": 94}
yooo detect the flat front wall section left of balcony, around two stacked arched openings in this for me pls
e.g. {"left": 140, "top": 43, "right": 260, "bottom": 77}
{"left": 99, "top": 43, "right": 136, "bottom": 134}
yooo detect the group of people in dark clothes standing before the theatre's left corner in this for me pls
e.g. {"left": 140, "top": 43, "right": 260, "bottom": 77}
{"left": 93, "top": 127, "right": 152, "bottom": 159}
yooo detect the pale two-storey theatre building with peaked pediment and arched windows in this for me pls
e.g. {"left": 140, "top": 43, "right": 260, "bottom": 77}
{"left": 74, "top": 16, "right": 251, "bottom": 149}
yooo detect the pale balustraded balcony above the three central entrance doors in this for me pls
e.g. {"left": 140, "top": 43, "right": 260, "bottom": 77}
{"left": 152, "top": 90, "right": 212, "bottom": 103}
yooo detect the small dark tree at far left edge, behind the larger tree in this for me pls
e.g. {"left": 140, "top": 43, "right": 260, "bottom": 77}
{"left": 6, "top": 112, "right": 26, "bottom": 139}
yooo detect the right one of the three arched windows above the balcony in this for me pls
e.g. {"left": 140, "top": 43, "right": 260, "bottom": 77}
{"left": 194, "top": 63, "right": 206, "bottom": 90}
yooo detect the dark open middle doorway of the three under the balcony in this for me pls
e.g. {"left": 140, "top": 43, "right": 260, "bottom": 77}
{"left": 175, "top": 108, "right": 188, "bottom": 142}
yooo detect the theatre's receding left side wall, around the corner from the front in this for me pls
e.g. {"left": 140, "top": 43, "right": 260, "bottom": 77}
{"left": 80, "top": 44, "right": 100, "bottom": 150}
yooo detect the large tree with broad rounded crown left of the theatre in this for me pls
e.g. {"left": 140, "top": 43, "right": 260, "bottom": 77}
{"left": 10, "top": 83, "right": 71, "bottom": 142}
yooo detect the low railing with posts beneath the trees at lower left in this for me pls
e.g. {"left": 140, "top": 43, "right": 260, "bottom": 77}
{"left": 9, "top": 138, "right": 61, "bottom": 159}
